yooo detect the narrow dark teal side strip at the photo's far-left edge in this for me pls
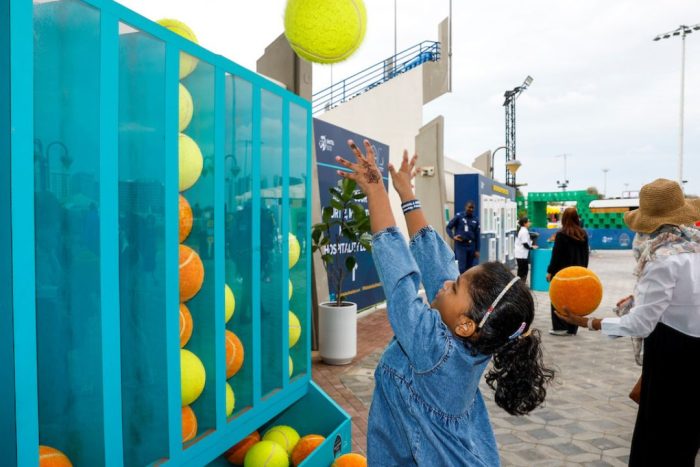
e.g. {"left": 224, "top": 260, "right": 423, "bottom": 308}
{"left": 0, "top": 2, "right": 17, "bottom": 458}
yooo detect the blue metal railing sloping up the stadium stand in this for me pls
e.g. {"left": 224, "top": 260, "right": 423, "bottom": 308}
{"left": 312, "top": 41, "right": 440, "bottom": 114}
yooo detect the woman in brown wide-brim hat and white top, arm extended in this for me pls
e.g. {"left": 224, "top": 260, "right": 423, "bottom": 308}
{"left": 559, "top": 179, "right": 700, "bottom": 467}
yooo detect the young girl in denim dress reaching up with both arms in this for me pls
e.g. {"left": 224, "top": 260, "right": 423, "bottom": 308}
{"left": 336, "top": 141, "right": 553, "bottom": 467}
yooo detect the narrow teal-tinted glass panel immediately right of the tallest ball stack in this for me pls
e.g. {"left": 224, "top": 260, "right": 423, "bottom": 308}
{"left": 224, "top": 75, "right": 253, "bottom": 414}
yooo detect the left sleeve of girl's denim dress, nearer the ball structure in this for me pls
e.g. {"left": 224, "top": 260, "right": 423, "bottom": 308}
{"left": 372, "top": 227, "right": 448, "bottom": 371}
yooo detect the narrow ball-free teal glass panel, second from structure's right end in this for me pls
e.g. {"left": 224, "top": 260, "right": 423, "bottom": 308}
{"left": 259, "top": 90, "right": 288, "bottom": 397}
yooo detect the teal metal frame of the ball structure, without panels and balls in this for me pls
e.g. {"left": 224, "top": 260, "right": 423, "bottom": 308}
{"left": 6, "top": 0, "right": 350, "bottom": 466}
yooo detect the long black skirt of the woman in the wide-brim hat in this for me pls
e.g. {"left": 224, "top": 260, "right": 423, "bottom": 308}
{"left": 629, "top": 323, "right": 700, "bottom": 467}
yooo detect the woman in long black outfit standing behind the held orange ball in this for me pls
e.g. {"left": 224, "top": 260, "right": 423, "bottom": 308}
{"left": 547, "top": 207, "right": 589, "bottom": 336}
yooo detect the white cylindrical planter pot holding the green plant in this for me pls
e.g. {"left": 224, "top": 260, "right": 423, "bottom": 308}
{"left": 318, "top": 302, "right": 357, "bottom": 365}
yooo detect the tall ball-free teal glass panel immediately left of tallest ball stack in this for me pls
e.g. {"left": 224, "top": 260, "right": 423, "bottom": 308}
{"left": 119, "top": 24, "right": 169, "bottom": 465}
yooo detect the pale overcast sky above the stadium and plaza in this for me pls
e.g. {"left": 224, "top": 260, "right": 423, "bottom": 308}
{"left": 120, "top": 0, "right": 700, "bottom": 196}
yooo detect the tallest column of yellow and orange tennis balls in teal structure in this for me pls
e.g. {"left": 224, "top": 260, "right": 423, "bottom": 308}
{"left": 158, "top": 19, "right": 208, "bottom": 443}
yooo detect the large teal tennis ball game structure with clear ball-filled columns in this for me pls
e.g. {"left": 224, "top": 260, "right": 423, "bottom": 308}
{"left": 0, "top": 0, "right": 351, "bottom": 466}
